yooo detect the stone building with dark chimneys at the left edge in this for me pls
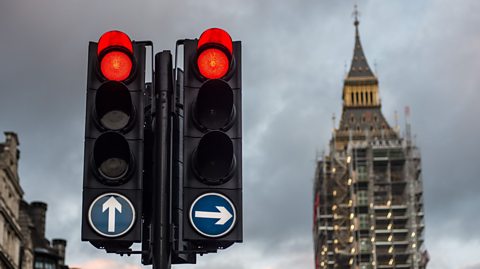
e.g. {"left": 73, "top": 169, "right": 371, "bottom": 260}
{"left": 0, "top": 132, "right": 68, "bottom": 269}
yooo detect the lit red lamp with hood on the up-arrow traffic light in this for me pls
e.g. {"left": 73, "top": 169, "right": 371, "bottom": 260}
{"left": 97, "top": 31, "right": 133, "bottom": 81}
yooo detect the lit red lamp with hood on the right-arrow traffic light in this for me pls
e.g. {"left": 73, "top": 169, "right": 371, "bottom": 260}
{"left": 197, "top": 28, "right": 233, "bottom": 79}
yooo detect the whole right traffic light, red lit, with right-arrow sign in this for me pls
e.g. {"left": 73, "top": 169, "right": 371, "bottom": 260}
{"left": 178, "top": 28, "right": 243, "bottom": 248}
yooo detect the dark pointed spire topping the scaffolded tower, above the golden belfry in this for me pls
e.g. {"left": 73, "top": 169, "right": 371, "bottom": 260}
{"left": 347, "top": 14, "right": 375, "bottom": 78}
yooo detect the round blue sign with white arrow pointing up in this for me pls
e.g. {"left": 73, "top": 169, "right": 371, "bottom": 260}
{"left": 88, "top": 193, "right": 135, "bottom": 237}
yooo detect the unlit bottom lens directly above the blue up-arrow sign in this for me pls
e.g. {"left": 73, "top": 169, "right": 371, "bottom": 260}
{"left": 93, "top": 132, "right": 131, "bottom": 182}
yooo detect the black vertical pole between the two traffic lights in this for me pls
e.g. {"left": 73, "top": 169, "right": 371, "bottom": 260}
{"left": 152, "top": 51, "right": 173, "bottom": 269}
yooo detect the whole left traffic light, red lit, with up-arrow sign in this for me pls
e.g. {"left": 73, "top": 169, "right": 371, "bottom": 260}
{"left": 82, "top": 31, "right": 146, "bottom": 251}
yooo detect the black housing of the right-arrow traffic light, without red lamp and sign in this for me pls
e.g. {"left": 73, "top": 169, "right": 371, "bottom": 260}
{"left": 179, "top": 30, "right": 243, "bottom": 248}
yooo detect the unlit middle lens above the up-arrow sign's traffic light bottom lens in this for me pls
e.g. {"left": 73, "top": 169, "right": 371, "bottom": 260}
{"left": 95, "top": 81, "right": 134, "bottom": 130}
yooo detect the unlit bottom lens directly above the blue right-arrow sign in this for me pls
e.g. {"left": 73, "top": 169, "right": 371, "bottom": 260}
{"left": 193, "top": 131, "right": 235, "bottom": 185}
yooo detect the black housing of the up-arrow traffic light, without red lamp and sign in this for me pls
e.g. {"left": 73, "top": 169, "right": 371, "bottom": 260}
{"left": 82, "top": 31, "right": 146, "bottom": 250}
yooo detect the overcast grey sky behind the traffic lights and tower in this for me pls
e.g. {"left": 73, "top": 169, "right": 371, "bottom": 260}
{"left": 0, "top": 0, "right": 480, "bottom": 269}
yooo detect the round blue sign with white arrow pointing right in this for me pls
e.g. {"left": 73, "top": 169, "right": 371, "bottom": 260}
{"left": 190, "top": 193, "right": 237, "bottom": 237}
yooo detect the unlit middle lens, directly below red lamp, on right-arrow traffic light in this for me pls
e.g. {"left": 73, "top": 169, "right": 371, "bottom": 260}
{"left": 194, "top": 80, "right": 233, "bottom": 130}
